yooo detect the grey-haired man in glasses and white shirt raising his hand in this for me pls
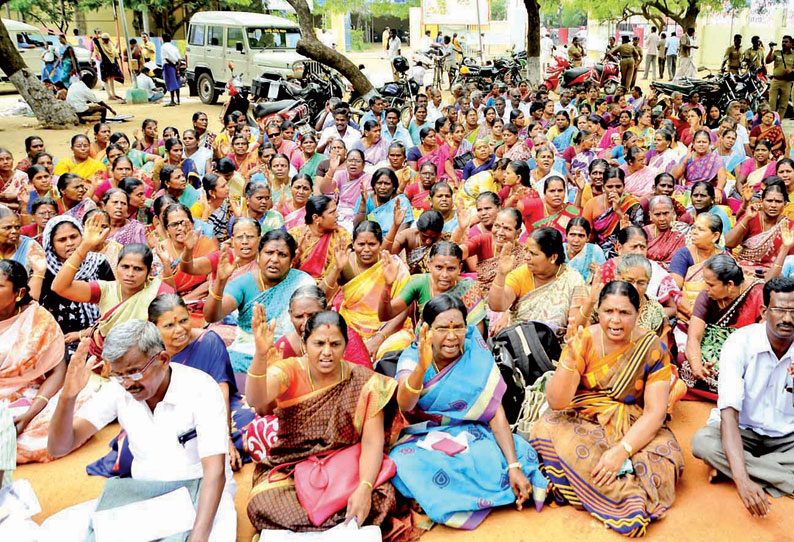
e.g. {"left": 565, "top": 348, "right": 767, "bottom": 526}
{"left": 47, "top": 320, "right": 237, "bottom": 542}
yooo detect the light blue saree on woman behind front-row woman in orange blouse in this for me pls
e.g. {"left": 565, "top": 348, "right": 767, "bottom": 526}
{"left": 229, "top": 269, "right": 317, "bottom": 373}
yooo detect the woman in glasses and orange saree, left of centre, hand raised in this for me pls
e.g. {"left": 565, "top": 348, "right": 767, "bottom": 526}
{"left": 150, "top": 203, "right": 217, "bottom": 301}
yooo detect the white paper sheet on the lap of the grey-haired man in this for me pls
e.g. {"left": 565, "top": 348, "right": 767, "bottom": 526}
{"left": 91, "top": 487, "right": 196, "bottom": 542}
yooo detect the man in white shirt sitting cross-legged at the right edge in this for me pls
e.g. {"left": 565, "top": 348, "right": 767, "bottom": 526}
{"left": 692, "top": 278, "right": 794, "bottom": 517}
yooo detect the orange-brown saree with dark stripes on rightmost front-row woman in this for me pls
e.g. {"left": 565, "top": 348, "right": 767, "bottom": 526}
{"left": 530, "top": 328, "right": 684, "bottom": 537}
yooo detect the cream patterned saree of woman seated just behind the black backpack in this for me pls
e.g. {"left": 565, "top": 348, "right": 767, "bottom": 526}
{"left": 508, "top": 265, "right": 584, "bottom": 331}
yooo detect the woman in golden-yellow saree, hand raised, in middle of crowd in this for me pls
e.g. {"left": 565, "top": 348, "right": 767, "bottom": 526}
{"left": 322, "top": 223, "right": 413, "bottom": 362}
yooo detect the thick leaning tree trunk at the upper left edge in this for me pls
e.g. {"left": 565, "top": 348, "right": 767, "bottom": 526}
{"left": 0, "top": 16, "right": 78, "bottom": 128}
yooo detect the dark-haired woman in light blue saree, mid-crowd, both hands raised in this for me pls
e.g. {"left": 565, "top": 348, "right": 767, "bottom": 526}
{"left": 354, "top": 168, "right": 414, "bottom": 235}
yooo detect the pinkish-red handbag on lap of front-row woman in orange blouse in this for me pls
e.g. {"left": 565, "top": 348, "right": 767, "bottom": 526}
{"left": 268, "top": 442, "right": 397, "bottom": 527}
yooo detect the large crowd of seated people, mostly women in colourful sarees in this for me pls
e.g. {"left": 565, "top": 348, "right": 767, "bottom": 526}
{"left": 0, "top": 68, "right": 794, "bottom": 541}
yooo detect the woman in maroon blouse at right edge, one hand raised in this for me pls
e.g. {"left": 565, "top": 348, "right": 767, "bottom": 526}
{"left": 725, "top": 181, "right": 790, "bottom": 275}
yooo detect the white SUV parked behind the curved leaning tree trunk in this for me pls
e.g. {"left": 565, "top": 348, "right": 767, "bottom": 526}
{"left": 185, "top": 11, "right": 307, "bottom": 104}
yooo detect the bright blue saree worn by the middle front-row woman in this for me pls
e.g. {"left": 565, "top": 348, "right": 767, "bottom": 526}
{"left": 389, "top": 326, "right": 548, "bottom": 530}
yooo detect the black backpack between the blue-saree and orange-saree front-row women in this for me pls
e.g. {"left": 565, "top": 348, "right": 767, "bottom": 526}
{"left": 491, "top": 322, "right": 562, "bottom": 424}
